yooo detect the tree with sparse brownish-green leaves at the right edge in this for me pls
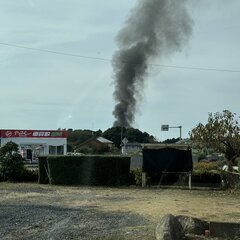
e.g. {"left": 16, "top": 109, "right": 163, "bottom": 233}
{"left": 190, "top": 110, "right": 240, "bottom": 167}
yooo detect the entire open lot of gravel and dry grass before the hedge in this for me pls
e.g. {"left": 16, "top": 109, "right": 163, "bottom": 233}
{"left": 0, "top": 183, "right": 240, "bottom": 240}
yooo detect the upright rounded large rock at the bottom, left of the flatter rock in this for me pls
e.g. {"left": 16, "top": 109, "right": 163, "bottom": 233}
{"left": 155, "top": 214, "right": 184, "bottom": 240}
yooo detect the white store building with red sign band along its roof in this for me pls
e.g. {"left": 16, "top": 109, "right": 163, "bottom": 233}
{"left": 0, "top": 130, "right": 67, "bottom": 161}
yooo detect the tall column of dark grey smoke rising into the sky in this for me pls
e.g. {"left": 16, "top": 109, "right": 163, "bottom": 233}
{"left": 112, "top": 0, "right": 192, "bottom": 127}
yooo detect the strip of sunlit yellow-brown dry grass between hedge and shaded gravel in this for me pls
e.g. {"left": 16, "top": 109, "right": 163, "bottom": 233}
{"left": 0, "top": 183, "right": 240, "bottom": 222}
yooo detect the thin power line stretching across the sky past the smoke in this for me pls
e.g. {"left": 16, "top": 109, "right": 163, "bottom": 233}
{"left": 0, "top": 42, "right": 240, "bottom": 73}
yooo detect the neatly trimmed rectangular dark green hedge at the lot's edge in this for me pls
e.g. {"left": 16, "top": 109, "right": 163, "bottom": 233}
{"left": 45, "top": 155, "right": 130, "bottom": 186}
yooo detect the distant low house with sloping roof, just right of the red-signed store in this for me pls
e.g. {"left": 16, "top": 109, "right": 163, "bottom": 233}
{"left": 79, "top": 137, "right": 114, "bottom": 153}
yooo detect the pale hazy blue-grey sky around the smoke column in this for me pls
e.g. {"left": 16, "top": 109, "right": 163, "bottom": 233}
{"left": 0, "top": 0, "right": 240, "bottom": 140}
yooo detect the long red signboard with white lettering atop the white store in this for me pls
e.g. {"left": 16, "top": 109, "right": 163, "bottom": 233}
{"left": 0, "top": 130, "right": 67, "bottom": 138}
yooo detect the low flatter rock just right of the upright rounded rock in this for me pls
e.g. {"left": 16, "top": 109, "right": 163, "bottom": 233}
{"left": 176, "top": 215, "right": 209, "bottom": 235}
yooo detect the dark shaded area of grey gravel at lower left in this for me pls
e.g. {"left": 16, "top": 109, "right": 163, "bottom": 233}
{"left": 0, "top": 204, "right": 154, "bottom": 240}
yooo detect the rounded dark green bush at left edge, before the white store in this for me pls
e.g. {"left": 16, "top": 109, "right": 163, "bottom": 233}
{"left": 0, "top": 142, "right": 24, "bottom": 181}
